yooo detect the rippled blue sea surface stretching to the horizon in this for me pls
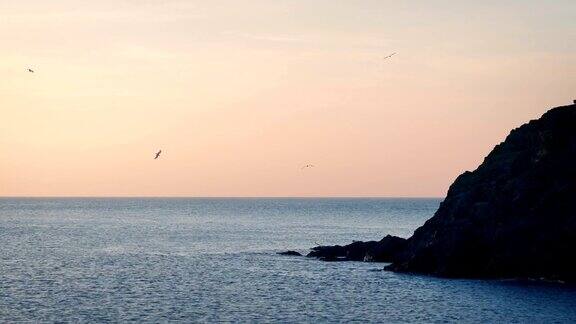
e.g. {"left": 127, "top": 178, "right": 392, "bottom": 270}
{"left": 0, "top": 198, "right": 576, "bottom": 323}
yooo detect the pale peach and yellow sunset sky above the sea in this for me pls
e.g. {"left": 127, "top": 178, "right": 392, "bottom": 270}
{"left": 0, "top": 0, "right": 576, "bottom": 197}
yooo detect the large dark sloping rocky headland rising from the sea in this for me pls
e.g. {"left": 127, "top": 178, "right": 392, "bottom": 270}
{"left": 310, "top": 105, "right": 576, "bottom": 282}
